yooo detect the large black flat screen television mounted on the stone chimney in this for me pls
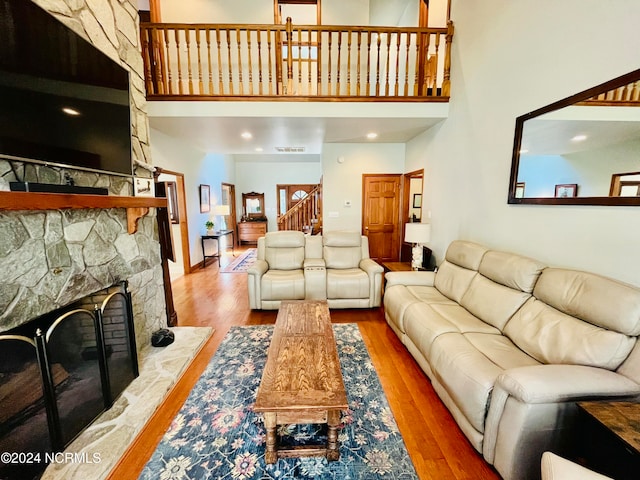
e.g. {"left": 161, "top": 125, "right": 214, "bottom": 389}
{"left": 0, "top": 0, "right": 132, "bottom": 176}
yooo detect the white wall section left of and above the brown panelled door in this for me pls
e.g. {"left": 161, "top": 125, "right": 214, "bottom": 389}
{"left": 322, "top": 143, "right": 405, "bottom": 232}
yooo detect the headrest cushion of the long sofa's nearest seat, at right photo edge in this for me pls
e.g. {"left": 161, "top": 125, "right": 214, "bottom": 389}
{"left": 534, "top": 268, "right": 640, "bottom": 336}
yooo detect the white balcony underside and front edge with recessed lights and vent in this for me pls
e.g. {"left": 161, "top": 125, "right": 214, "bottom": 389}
{"left": 148, "top": 102, "right": 448, "bottom": 156}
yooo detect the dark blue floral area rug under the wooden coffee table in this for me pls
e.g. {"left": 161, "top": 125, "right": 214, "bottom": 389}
{"left": 140, "top": 324, "right": 418, "bottom": 480}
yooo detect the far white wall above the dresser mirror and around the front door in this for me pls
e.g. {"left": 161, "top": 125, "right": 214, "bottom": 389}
{"left": 235, "top": 155, "right": 322, "bottom": 232}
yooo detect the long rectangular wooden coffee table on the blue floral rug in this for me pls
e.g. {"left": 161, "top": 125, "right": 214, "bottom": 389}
{"left": 254, "top": 300, "right": 349, "bottom": 463}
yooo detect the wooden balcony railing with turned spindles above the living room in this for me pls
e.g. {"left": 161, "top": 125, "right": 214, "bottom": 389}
{"left": 140, "top": 19, "right": 453, "bottom": 101}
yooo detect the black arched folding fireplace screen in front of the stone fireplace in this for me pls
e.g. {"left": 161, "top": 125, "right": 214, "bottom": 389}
{"left": 0, "top": 282, "right": 138, "bottom": 480}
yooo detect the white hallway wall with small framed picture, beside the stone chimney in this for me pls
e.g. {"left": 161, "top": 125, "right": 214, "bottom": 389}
{"left": 150, "top": 129, "right": 235, "bottom": 266}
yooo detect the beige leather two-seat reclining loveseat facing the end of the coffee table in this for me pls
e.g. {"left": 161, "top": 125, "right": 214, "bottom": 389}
{"left": 247, "top": 231, "right": 384, "bottom": 310}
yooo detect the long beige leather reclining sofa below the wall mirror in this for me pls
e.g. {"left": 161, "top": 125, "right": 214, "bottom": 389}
{"left": 384, "top": 241, "right": 640, "bottom": 480}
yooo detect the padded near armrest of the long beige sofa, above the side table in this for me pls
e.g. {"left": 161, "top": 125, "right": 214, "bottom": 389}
{"left": 496, "top": 365, "right": 640, "bottom": 403}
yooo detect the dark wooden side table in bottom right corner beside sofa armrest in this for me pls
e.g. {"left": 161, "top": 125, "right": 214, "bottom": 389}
{"left": 576, "top": 401, "right": 640, "bottom": 480}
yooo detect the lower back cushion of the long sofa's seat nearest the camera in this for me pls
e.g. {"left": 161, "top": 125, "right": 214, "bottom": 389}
{"left": 504, "top": 298, "right": 636, "bottom": 370}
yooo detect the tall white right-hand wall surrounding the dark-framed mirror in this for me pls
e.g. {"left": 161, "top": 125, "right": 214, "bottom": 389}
{"left": 416, "top": 0, "right": 640, "bottom": 285}
